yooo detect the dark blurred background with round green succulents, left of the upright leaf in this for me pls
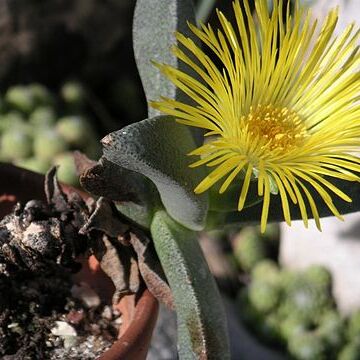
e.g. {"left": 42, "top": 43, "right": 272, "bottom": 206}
{"left": 0, "top": 0, "right": 146, "bottom": 185}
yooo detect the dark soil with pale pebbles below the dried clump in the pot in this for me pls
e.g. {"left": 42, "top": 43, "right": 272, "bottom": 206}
{"left": 0, "top": 266, "right": 121, "bottom": 360}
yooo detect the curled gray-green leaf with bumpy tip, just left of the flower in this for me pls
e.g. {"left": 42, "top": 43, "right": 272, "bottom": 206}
{"left": 102, "top": 116, "right": 208, "bottom": 230}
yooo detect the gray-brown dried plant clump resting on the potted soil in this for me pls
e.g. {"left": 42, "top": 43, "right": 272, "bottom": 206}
{"left": 0, "top": 169, "right": 91, "bottom": 271}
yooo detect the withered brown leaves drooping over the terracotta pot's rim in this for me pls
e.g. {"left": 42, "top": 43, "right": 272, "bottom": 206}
{"left": 80, "top": 191, "right": 173, "bottom": 309}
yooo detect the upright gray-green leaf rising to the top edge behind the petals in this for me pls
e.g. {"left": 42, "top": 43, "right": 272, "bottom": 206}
{"left": 133, "top": 0, "right": 195, "bottom": 117}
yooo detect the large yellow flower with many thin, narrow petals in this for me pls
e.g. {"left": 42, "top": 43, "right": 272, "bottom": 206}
{"left": 152, "top": 0, "right": 360, "bottom": 231}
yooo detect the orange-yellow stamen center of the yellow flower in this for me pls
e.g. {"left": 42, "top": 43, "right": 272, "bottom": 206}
{"left": 243, "top": 105, "right": 307, "bottom": 151}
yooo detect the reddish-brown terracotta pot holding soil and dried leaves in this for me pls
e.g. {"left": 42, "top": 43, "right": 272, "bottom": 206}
{"left": 0, "top": 163, "right": 158, "bottom": 360}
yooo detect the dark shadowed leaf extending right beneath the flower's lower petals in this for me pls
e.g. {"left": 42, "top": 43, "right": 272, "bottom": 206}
{"left": 207, "top": 177, "right": 360, "bottom": 229}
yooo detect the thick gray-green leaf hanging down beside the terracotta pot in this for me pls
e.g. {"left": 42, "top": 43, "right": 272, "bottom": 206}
{"left": 151, "top": 211, "right": 230, "bottom": 360}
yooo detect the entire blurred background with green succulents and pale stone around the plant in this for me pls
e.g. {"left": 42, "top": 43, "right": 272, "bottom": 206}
{"left": 0, "top": 0, "right": 360, "bottom": 360}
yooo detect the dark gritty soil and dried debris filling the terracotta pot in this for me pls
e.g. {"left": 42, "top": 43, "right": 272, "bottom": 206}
{"left": 0, "top": 168, "right": 121, "bottom": 360}
